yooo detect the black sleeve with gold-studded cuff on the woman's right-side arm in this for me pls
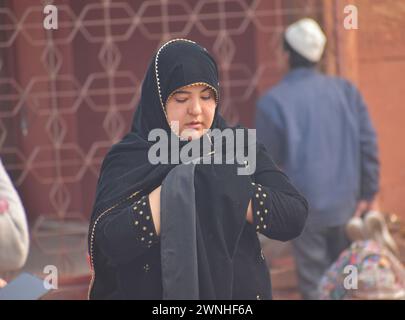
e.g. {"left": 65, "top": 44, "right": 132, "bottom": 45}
{"left": 252, "top": 144, "right": 308, "bottom": 241}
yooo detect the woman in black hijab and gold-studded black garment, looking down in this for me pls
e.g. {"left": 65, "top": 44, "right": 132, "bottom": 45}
{"left": 89, "top": 39, "right": 307, "bottom": 299}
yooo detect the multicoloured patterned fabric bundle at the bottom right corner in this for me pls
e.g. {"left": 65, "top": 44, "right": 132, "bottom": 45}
{"left": 319, "top": 240, "right": 405, "bottom": 300}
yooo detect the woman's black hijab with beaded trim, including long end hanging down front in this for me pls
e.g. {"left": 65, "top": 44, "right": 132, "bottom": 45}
{"left": 89, "top": 39, "right": 251, "bottom": 299}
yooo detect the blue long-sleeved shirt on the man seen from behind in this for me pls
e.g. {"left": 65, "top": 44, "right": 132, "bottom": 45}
{"left": 256, "top": 68, "right": 379, "bottom": 227}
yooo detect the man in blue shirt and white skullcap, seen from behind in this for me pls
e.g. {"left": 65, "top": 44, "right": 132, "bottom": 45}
{"left": 256, "top": 18, "right": 379, "bottom": 299}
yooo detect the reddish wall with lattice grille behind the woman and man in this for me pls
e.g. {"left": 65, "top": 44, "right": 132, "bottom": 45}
{"left": 0, "top": 0, "right": 405, "bottom": 299}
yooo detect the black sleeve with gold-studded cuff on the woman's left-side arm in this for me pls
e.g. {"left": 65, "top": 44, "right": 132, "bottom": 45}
{"left": 95, "top": 195, "right": 159, "bottom": 265}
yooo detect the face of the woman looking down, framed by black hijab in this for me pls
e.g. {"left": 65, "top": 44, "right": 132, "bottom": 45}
{"left": 166, "top": 85, "right": 216, "bottom": 140}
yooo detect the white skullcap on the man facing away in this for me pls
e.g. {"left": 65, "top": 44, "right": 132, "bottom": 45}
{"left": 285, "top": 18, "right": 326, "bottom": 62}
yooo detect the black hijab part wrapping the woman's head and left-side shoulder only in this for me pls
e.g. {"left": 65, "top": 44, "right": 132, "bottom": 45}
{"left": 92, "top": 39, "right": 227, "bottom": 221}
